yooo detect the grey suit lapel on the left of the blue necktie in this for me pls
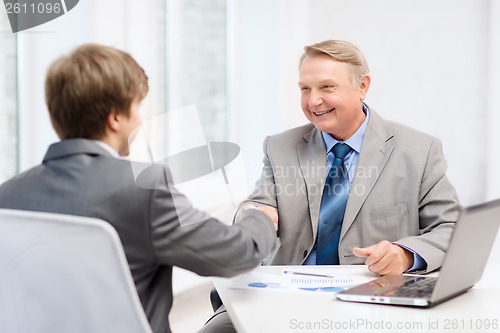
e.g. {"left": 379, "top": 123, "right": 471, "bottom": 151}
{"left": 297, "top": 128, "right": 326, "bottom": 237}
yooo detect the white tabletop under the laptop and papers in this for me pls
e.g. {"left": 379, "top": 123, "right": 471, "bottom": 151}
{"left": 213, "top": 265, "right": 500, "bottom": 333}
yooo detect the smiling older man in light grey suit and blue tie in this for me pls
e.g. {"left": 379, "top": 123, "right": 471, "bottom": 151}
{"left": 201, "top": 40, "right": 459, "bottom": 332}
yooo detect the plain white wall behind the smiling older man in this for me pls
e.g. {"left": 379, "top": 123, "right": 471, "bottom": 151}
{"left": 232, "top": 0, "right": 500, "bottom": 204}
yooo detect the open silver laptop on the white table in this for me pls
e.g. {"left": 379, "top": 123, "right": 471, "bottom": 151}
{"left": 337, "top": 199, "right": 500, "bottom": 307}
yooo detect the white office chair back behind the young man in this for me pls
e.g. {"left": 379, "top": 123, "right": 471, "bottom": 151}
{"left": 0, "top": 209, "right": 152, "bottom": 333}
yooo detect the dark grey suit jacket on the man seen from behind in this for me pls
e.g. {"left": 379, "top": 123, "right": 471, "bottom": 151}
{"left": 0, "top": 139, "right": 276, "bottom": 332}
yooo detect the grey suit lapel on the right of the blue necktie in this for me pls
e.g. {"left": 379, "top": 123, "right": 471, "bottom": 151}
{"left": 340, "top": 109, "right": 394, "bottom": 240}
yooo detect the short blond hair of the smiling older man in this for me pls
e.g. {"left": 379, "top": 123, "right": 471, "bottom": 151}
{"left": 299, "top": 40, "right": 369, "bottom": 87}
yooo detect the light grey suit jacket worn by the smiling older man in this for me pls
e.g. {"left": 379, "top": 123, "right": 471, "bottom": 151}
{"left": 236, "top": 110, "right": 460, "bottom": 271}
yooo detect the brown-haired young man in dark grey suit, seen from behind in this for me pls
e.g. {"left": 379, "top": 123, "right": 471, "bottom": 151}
{"left": 0, "top": 44, "right": 277, "bottom": 332}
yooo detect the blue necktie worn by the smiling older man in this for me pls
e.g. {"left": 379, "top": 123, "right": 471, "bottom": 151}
{"left": 316, "top": 143, "right": 351, "bottom": 265}
